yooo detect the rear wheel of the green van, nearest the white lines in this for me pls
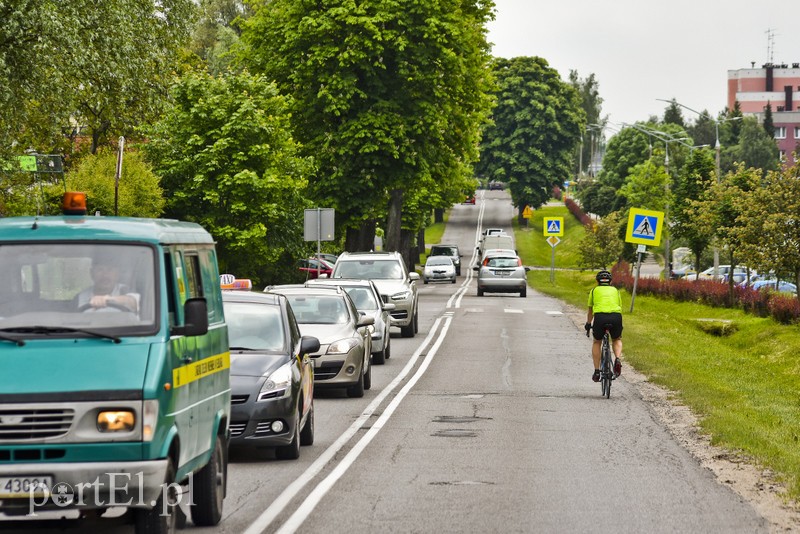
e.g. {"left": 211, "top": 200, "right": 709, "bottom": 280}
{"left": 190, "top": 436, "right": 228, "bottom": 527}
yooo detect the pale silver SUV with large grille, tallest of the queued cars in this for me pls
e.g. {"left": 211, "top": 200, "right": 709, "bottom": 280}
{"left": 331, "top": 252, "right": 420, "bottom": 337}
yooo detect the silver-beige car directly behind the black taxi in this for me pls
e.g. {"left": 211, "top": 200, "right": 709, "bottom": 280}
{"left": 265, "top": 285, "right": 375, "bottom": 397}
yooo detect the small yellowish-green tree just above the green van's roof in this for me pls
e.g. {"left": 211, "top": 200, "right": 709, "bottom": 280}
{"left": 66, "top": 148, "right": 164, "bottom": 217}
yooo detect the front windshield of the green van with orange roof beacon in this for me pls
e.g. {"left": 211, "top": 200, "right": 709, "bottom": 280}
{"left": 0, "top": 242, "right": 156, "bottom": 337}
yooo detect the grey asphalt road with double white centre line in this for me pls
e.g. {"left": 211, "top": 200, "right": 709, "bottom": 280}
{"left": 4, "top": 191, "right": 769, "bottom": 534}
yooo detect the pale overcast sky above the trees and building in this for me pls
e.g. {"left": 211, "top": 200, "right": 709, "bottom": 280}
{"left": 488, "top": 0, "right": 800, "bottom": 129}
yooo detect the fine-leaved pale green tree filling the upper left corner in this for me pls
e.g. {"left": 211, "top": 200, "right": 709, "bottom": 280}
{"left": 0, "top": 0, "right": 194, "bottom": 159}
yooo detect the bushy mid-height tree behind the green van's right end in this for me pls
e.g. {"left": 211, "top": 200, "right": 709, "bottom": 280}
{"left": 144, "top": 72, "right": 312, "bottom": 284}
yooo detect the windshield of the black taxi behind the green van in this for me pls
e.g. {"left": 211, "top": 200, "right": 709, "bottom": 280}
{"left": 225, "top": 302, "right": 285, "bottom": 351}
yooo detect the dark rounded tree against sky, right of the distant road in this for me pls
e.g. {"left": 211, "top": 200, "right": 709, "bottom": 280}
{"left": 477, "top": 57, "right": 585, "bottom": 218}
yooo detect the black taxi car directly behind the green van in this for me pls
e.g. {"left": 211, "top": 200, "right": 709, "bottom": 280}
{"left": 222, "top": 286, "right": 320, "bottom": 460}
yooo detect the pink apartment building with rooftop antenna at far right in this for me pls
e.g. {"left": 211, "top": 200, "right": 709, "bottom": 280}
{"left": 728, "top": 63, "right": 800, "bottom": 164}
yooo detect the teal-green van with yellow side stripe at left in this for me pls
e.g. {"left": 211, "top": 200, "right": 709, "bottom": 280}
{"left": 0, "top": 195, "right": 230, "bottom": 532}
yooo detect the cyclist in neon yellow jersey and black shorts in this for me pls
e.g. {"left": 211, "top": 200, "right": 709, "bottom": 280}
{"left": 584, "top": 269, "right": 622, "bottom": 382}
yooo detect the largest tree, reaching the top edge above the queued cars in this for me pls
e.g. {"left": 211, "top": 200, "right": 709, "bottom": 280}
{"left": 242, "top": 0, "right": 494, "bottom": 259}
